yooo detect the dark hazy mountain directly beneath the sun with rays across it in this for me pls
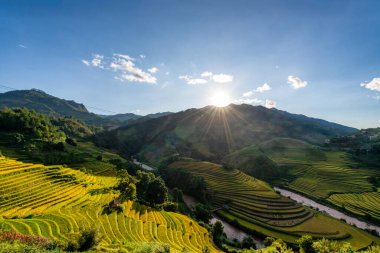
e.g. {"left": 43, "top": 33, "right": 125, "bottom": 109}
{"left": 97, "top": 104, "right": 356, "bottom": 161}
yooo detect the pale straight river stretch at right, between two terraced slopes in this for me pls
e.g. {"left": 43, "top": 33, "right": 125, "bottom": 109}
{"left": 273, "top": 187, "right": 380, "bottom": 235}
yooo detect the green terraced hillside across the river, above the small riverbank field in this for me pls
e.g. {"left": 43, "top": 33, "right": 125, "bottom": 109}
{"left": 260, "top": 139, "right": 380, "bottom": 199}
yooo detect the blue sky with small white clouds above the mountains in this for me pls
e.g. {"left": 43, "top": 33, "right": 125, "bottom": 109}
{"left": 0, "top": 0, "right": 380, "bottom": 128}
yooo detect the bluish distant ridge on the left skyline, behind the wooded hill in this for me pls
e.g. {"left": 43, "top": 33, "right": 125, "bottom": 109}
{"left": 0, "top": 89, "right": 170, "bottom": 128}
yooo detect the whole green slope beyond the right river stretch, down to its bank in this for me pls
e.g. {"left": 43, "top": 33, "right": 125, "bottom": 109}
{"left": 225, "top": 139, "right": 380, "bottom": 220}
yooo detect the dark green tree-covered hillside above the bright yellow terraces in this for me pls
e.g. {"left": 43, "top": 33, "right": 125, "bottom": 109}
{"left": 0, "top": 108, "right": 119, "bottom": 169}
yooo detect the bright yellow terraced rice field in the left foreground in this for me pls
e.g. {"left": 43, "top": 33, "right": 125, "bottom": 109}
{"left": 0, "top": 157, "right": 218, "bottom": 252}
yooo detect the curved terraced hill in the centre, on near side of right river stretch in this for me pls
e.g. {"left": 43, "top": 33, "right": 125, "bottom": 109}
{"left": 170, "top": 160, "right": 377, "bottom": 248}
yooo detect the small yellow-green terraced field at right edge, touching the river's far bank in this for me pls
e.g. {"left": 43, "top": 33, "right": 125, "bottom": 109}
{"left": 327, "top": 192, "right": 380, "bottom": 220}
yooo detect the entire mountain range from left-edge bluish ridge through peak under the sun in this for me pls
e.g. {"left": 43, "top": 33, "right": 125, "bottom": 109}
{"left": 0, "top": 89, "right": 357, "bottom": 162}
